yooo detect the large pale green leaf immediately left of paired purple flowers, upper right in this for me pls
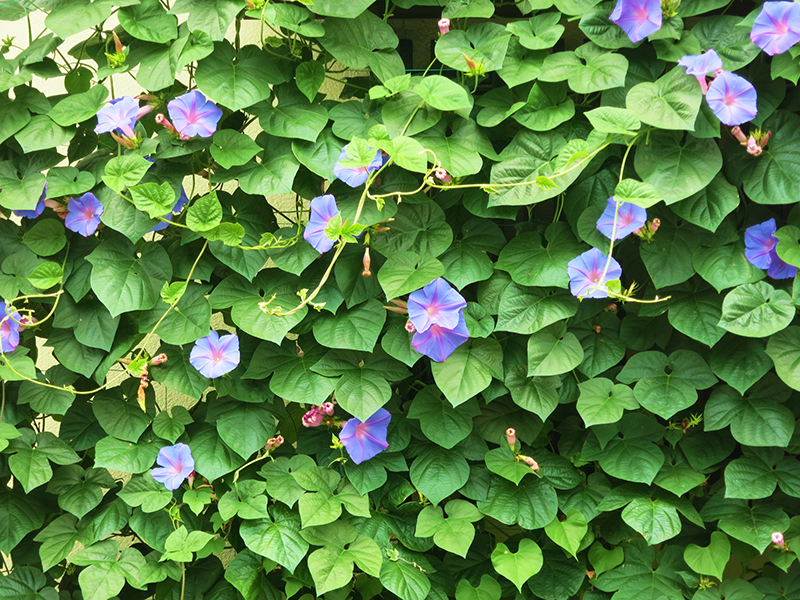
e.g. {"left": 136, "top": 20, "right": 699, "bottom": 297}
{"left": 625, "top": 67, "right": 700, "bottom": 131}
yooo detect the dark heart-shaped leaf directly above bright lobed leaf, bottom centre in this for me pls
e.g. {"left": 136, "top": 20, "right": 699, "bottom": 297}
{"left": 409, "top": 444, "right": 469, "bottom": 505}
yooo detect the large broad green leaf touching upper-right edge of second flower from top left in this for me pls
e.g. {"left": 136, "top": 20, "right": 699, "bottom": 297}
{"left": 195, "top": 42, "right": 286, "bottom": 110}
